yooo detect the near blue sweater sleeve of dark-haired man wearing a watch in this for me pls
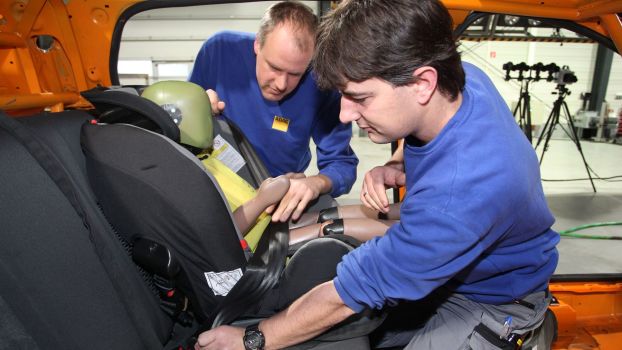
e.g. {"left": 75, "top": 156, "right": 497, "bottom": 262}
{"left": 334, "top": 203, "right": 482, "bottom": 311}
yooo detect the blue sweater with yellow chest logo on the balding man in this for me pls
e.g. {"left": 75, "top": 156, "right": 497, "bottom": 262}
{"left": 189, "top": 31, "right": 358, "bottom": 197}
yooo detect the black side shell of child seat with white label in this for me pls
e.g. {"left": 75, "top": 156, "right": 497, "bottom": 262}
{"left": 82, "top": 124, "right": 256, "bottom": 321}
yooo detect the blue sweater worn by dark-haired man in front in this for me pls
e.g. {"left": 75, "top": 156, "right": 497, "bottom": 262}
{"left": 334, "top": 63, "right": 559, "bottom": 311}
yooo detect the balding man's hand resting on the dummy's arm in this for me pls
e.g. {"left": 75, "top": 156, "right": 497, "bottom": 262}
{"left": 266, "top": 173, "right": 332, "bottom": 222}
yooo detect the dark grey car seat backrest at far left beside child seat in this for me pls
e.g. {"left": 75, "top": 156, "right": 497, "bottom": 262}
{"left": 0, "top": 111, "right": 180, "bottom": 349}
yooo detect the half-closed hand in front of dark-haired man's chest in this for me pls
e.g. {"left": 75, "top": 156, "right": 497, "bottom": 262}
{"left": 361, "top": 165, "right": 406, "bottom": 213}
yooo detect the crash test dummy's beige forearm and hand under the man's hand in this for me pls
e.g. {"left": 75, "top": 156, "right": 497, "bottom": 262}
{"left": 233, "top": 175, "right": 289, "bottom": 234}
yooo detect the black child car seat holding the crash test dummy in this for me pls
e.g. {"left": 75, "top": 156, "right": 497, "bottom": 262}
{"left": 82, "top": 91, "right": 381, "bottom": 348}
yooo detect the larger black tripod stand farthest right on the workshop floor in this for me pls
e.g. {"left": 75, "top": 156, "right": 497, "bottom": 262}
{"left": 535, "top": 83, "right": 596, "bottom": 193}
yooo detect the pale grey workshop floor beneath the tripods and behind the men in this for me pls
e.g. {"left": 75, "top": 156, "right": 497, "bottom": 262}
{"left": 308, "top": 126, "right": 622, "bottom": 274}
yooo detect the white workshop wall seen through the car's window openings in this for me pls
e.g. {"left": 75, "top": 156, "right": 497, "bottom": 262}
{"left": 119, "top": 1, "right": 622, "bottom": 124}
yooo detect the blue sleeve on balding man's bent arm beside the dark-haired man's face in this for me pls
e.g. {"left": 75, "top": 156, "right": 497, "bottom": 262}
{"left": 312, "top": 92, "right": 359, "bottom": 197}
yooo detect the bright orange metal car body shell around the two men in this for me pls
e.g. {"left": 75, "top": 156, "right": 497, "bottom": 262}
{"left": 0, "top": 0, "right": 622, "bottom": 350}
